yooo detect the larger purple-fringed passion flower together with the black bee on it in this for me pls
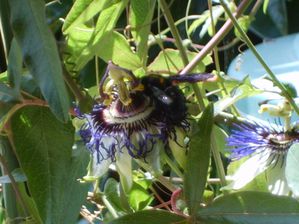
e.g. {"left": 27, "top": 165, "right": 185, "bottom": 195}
{"left": 80, "top": 62, "right": 213, "bottom": 176}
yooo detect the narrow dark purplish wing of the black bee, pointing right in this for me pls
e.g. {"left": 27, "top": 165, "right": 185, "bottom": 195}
{"left": 169, "top": 73, "right": 215, "bottom": 83}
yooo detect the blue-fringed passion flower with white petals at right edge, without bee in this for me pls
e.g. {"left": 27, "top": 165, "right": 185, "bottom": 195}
{"left": 226, "top": 122, "right": 299, "bottom": 195}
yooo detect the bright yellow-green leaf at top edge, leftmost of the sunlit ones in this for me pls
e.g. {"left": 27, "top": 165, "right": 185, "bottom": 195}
{"left": 62, "top": 0, "right": 111, "bottom": 34}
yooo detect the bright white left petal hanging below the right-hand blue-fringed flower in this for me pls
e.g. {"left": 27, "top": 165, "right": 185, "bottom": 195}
{"left": 224, "top": 150, "right": 271, "bottom": 190}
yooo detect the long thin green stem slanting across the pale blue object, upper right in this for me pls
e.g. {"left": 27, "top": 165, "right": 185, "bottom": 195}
{"left": 220, "top": 0, "right": 299, "bottom": 114}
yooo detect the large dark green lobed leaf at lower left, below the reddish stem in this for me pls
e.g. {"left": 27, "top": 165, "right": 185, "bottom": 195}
{"left": 11, "top": 106, "right": 88, "bottom": 224}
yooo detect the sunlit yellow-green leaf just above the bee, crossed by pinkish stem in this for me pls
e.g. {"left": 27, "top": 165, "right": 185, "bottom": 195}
{"left": 148, "top": 48, "right": 213, "bottom": 74}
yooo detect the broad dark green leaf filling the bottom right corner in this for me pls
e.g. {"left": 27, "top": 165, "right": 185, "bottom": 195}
{"left": 198, "top": 191, "right": 299, "bottom": 224}
